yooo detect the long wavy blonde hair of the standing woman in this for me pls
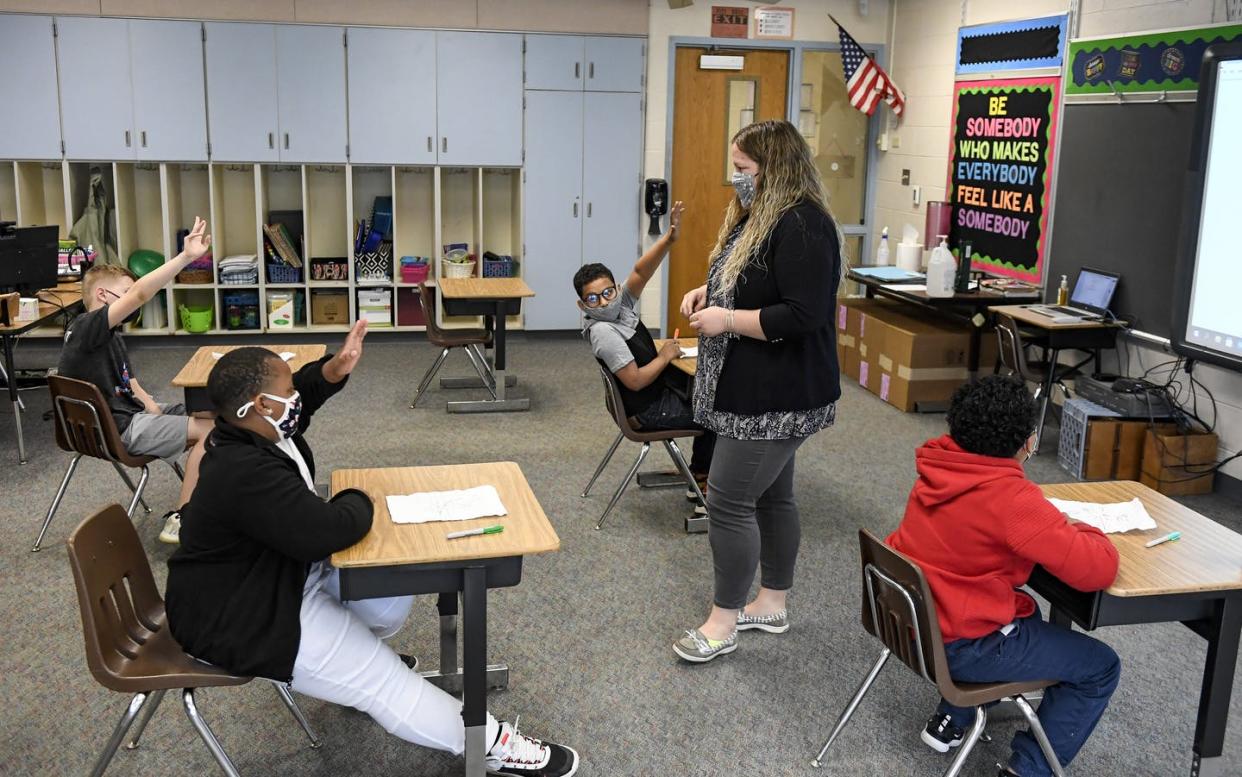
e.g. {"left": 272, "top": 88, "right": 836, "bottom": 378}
{"left": 710, "top": 120, "right": 845, "bottom": 292}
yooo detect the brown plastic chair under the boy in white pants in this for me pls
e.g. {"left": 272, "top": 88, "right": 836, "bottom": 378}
{"left": 68, "top": 504, "right": 319, "bottom": 777}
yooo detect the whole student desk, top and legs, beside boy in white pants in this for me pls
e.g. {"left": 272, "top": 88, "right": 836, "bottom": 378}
{"left": 332, "top": 462, "right": 560, "bottom": 777}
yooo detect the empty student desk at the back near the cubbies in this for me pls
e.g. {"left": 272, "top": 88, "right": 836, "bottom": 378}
{"left": 437, "top": 278, "right": 535, "bottom": 413}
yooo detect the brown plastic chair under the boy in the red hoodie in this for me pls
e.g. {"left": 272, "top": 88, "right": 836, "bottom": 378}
{"left": 811, "top": 529, "right": 1063, "bottom": 777}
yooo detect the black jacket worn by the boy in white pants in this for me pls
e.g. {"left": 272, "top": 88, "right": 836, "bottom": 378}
{"left": 166, "top": 356, "right": 371, "bottom": 681}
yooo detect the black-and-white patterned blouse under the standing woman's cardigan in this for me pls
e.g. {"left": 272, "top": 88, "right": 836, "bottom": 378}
{"left": 692, "top": 221, "right": 837, "bottom": 439}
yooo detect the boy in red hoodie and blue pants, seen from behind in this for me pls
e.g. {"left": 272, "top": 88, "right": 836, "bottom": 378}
{"left": 887, "top": 376, "right": 1120, "bottom": 777}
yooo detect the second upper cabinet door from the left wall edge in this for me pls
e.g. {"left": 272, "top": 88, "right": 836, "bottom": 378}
{"left": 57, "top": 16, "right": 134, "bottom": 160}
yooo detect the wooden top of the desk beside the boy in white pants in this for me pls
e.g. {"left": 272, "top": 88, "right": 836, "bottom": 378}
{"left": 332, "top": 462, "right": 560, "bottom": 567}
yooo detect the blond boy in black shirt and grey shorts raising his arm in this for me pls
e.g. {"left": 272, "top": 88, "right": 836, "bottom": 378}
{"left": 58, "top": 217, "right": 211, "bottom": 545}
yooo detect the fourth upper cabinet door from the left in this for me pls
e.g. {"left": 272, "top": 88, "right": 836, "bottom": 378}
{"left": 204, "top": 21, "right": 279, "bottom": 161}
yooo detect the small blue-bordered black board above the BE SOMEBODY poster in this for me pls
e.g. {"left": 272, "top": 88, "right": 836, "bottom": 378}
{"left": 956, "top": 14, "right": 1069, "bottom": 76}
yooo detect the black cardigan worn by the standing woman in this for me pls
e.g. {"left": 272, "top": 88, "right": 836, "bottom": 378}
{"left": 715, "top": 202, "right": 841, "bottom": 416}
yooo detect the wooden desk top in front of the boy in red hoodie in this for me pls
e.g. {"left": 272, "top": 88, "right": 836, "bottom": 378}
{"left": 1041, "top": 480, "right": 1242, "bottom": 596}
